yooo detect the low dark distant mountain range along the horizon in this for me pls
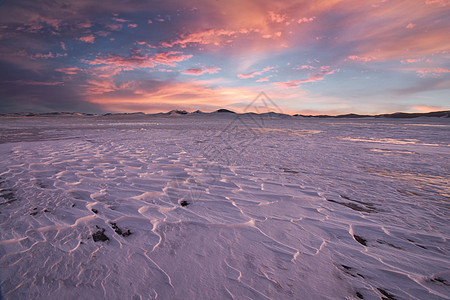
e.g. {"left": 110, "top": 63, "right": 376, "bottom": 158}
{"left": 0, "top": 108, "right": 450, "bottom": 119}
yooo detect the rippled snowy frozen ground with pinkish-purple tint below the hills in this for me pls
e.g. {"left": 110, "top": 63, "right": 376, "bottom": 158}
{"left": 0, "top": 114, "right": 450, "bottom": 299}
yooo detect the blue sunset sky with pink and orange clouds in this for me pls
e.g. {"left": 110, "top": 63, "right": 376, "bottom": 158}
{"left": 0, "top": 0, "right": 450, "bottom": 115}
